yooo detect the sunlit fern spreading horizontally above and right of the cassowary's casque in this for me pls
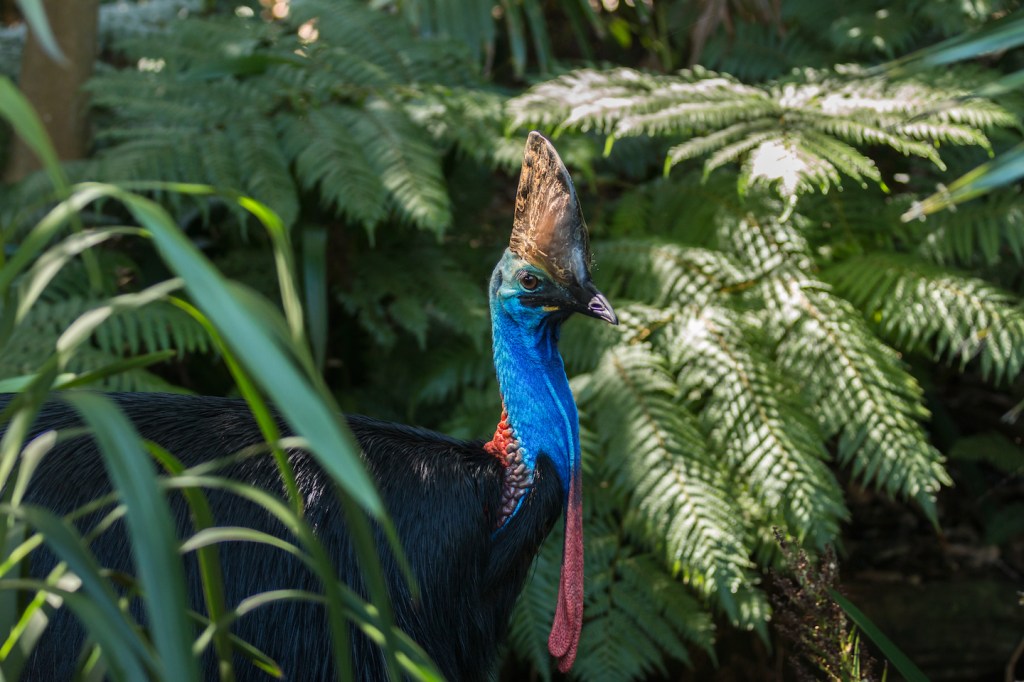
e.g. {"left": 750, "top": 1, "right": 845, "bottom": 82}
{"left": 510, "top": 63, "right": 1017, "bottom": 201}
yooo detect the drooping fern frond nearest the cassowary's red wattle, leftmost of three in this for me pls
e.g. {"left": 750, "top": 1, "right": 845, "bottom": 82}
{"left": 579, "top": 345, "right": 754, "bottom": 626}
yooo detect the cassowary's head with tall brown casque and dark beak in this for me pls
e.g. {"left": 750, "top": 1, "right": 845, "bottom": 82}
{"left": 492, "top": 131, "right": 618, "bottom": 328}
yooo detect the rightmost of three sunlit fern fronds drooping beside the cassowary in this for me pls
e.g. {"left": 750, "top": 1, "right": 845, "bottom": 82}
{"left": 728, "top": 219, "right": 949, "bottom": 518}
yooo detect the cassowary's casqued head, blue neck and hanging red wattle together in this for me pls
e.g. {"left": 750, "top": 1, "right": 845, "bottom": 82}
{"left": 486, "top": 132, "right": 618, "bottom": 672}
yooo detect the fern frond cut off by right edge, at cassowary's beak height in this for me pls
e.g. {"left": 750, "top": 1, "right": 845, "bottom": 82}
{"left": 823, "top": 252, "right": 1024, "bottom": 383}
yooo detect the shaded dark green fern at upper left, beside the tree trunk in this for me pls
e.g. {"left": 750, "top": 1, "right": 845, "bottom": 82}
{"left": 30, "top": 0, "right": 507, "bottom": 233}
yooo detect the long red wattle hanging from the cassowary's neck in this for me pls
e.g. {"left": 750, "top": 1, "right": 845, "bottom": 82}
{"left": 548, "top": 472, "right": 583, "bottom": 673}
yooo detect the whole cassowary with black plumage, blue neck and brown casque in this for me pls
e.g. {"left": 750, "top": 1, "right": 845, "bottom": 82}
{"left": 8, "top": 132, "right": 617, "bottom": 680}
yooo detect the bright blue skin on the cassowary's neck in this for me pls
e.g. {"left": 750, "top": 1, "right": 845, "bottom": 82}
{"left": 490, "top": 249, "right": 580, "bottom": 509}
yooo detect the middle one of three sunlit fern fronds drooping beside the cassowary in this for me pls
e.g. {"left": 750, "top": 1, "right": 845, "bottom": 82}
{"left": 669, "top": 307, "right": 847, "bottom": 546}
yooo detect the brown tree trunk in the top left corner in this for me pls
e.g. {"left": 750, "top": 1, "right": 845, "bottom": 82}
{"left": 4, "top": 0, "right": 99, "bottom": 182}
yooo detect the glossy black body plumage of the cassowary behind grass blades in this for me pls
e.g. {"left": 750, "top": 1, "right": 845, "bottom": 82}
{"left": 14, "top": 393, "right": 562, "bottom": 680}
